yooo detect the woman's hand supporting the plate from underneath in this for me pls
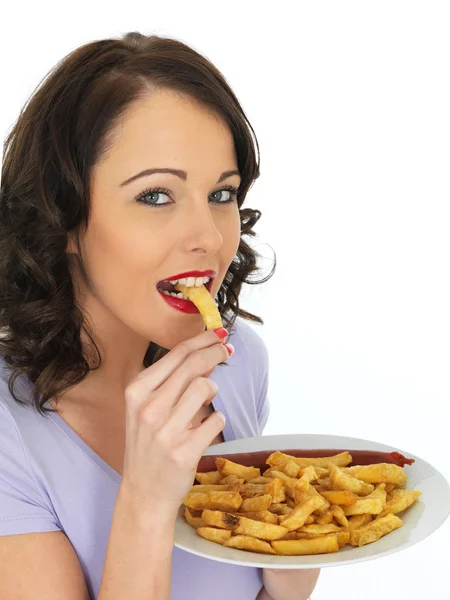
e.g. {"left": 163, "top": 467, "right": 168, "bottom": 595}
{"left": 263, "top": 569, "right": 320, "bottom": 600}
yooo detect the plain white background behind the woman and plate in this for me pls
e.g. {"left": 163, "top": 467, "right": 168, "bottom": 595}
{"left": 0, "top": 0, "right": 450, "bottom": 600}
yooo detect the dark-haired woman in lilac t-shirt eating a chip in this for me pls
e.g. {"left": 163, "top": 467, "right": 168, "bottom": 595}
{"left": 0, "top": 33, "right": 319, "bottom": 600}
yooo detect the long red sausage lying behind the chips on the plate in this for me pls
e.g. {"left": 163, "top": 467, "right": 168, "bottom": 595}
{"left": 197, "top": 448, "right": 415, "bottom": 475}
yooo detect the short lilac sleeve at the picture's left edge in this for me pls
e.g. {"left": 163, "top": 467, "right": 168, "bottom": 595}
{"left": 0, "top": 400, "right": 61, "bottom": 535}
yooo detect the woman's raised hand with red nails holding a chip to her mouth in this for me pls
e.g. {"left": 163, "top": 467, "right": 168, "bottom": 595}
{"left": 120, "top": 331, "right": 230, "bottom": 522}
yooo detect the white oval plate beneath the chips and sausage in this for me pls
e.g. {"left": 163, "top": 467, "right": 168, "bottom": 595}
{"left": 175, "top": 434, "right": 450, "bottom": 569}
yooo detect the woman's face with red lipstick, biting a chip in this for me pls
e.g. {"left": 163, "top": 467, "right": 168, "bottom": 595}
{"left": 68, "top": 91, "right": 240, "bottom": 349}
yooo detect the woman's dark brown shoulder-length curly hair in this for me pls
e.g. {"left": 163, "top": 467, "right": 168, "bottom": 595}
{"left": 0, "top": 32, "right": 276, "bottom": 415}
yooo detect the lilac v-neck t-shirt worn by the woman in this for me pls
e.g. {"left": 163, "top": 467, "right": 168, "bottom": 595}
{"left": 0, "top": 317, "right": 269, "bottom": 600}
